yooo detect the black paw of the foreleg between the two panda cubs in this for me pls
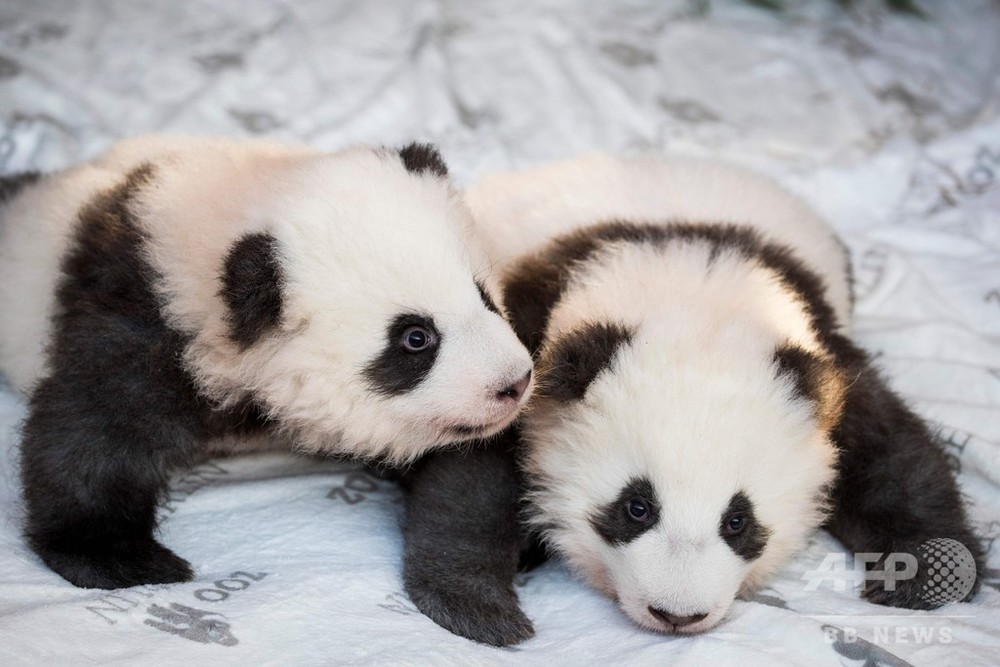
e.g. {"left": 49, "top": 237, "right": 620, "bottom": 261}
{"left": 406, "top": 577, "right": 535, "bottom": 646}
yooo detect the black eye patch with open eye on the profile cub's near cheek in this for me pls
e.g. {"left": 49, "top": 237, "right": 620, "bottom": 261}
{"left": 364, "top": 314, "right": 441, "bottom": 396}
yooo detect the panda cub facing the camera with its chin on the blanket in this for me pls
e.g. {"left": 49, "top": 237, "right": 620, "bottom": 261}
{"left": 407, "top": 156, "right": 982, "bottom": 643}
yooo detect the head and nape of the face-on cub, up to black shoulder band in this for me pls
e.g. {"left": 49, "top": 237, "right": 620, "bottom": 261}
{"left": 505, "top": 224, "right": 843, "bottom": 633}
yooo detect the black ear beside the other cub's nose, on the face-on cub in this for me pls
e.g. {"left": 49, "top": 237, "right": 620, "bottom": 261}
{"left": 538, "top": 322, "right": 633, "bottom": 401}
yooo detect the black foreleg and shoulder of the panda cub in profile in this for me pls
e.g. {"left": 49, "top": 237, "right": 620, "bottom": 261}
{"left": 15, "top": 165, "right": 219, "bottom": 588}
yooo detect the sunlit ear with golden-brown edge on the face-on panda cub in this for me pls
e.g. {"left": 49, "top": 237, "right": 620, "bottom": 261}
{"left": 774, "top": 343, "right": 847, "bottom": 431}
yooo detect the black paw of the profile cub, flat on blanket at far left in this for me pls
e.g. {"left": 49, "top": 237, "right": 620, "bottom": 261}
{"left": 38, "top": 539, "right": 194, "bottom": 589}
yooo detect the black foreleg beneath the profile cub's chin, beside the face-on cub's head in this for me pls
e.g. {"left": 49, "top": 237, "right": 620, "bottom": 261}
{"left": 403, "top": 429, "right": 534, "bottom": 646}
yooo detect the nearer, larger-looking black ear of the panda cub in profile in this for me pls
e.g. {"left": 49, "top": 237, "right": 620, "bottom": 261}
{"left": 219, "top": 232, "right": 282, "bottom": 350}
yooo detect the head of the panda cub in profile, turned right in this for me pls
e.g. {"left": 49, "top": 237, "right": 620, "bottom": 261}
{"left": 164, "top": 144, "right": 532, "bottom": 462}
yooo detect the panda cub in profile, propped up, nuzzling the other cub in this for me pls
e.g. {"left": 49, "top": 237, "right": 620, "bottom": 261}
{"left": 0, "top": 137, "right": 531, "bottom": 588}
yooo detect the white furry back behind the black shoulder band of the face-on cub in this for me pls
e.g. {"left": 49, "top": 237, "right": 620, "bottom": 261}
{"left": 465, "top": 153, "right": 851, "bottom": 330}
